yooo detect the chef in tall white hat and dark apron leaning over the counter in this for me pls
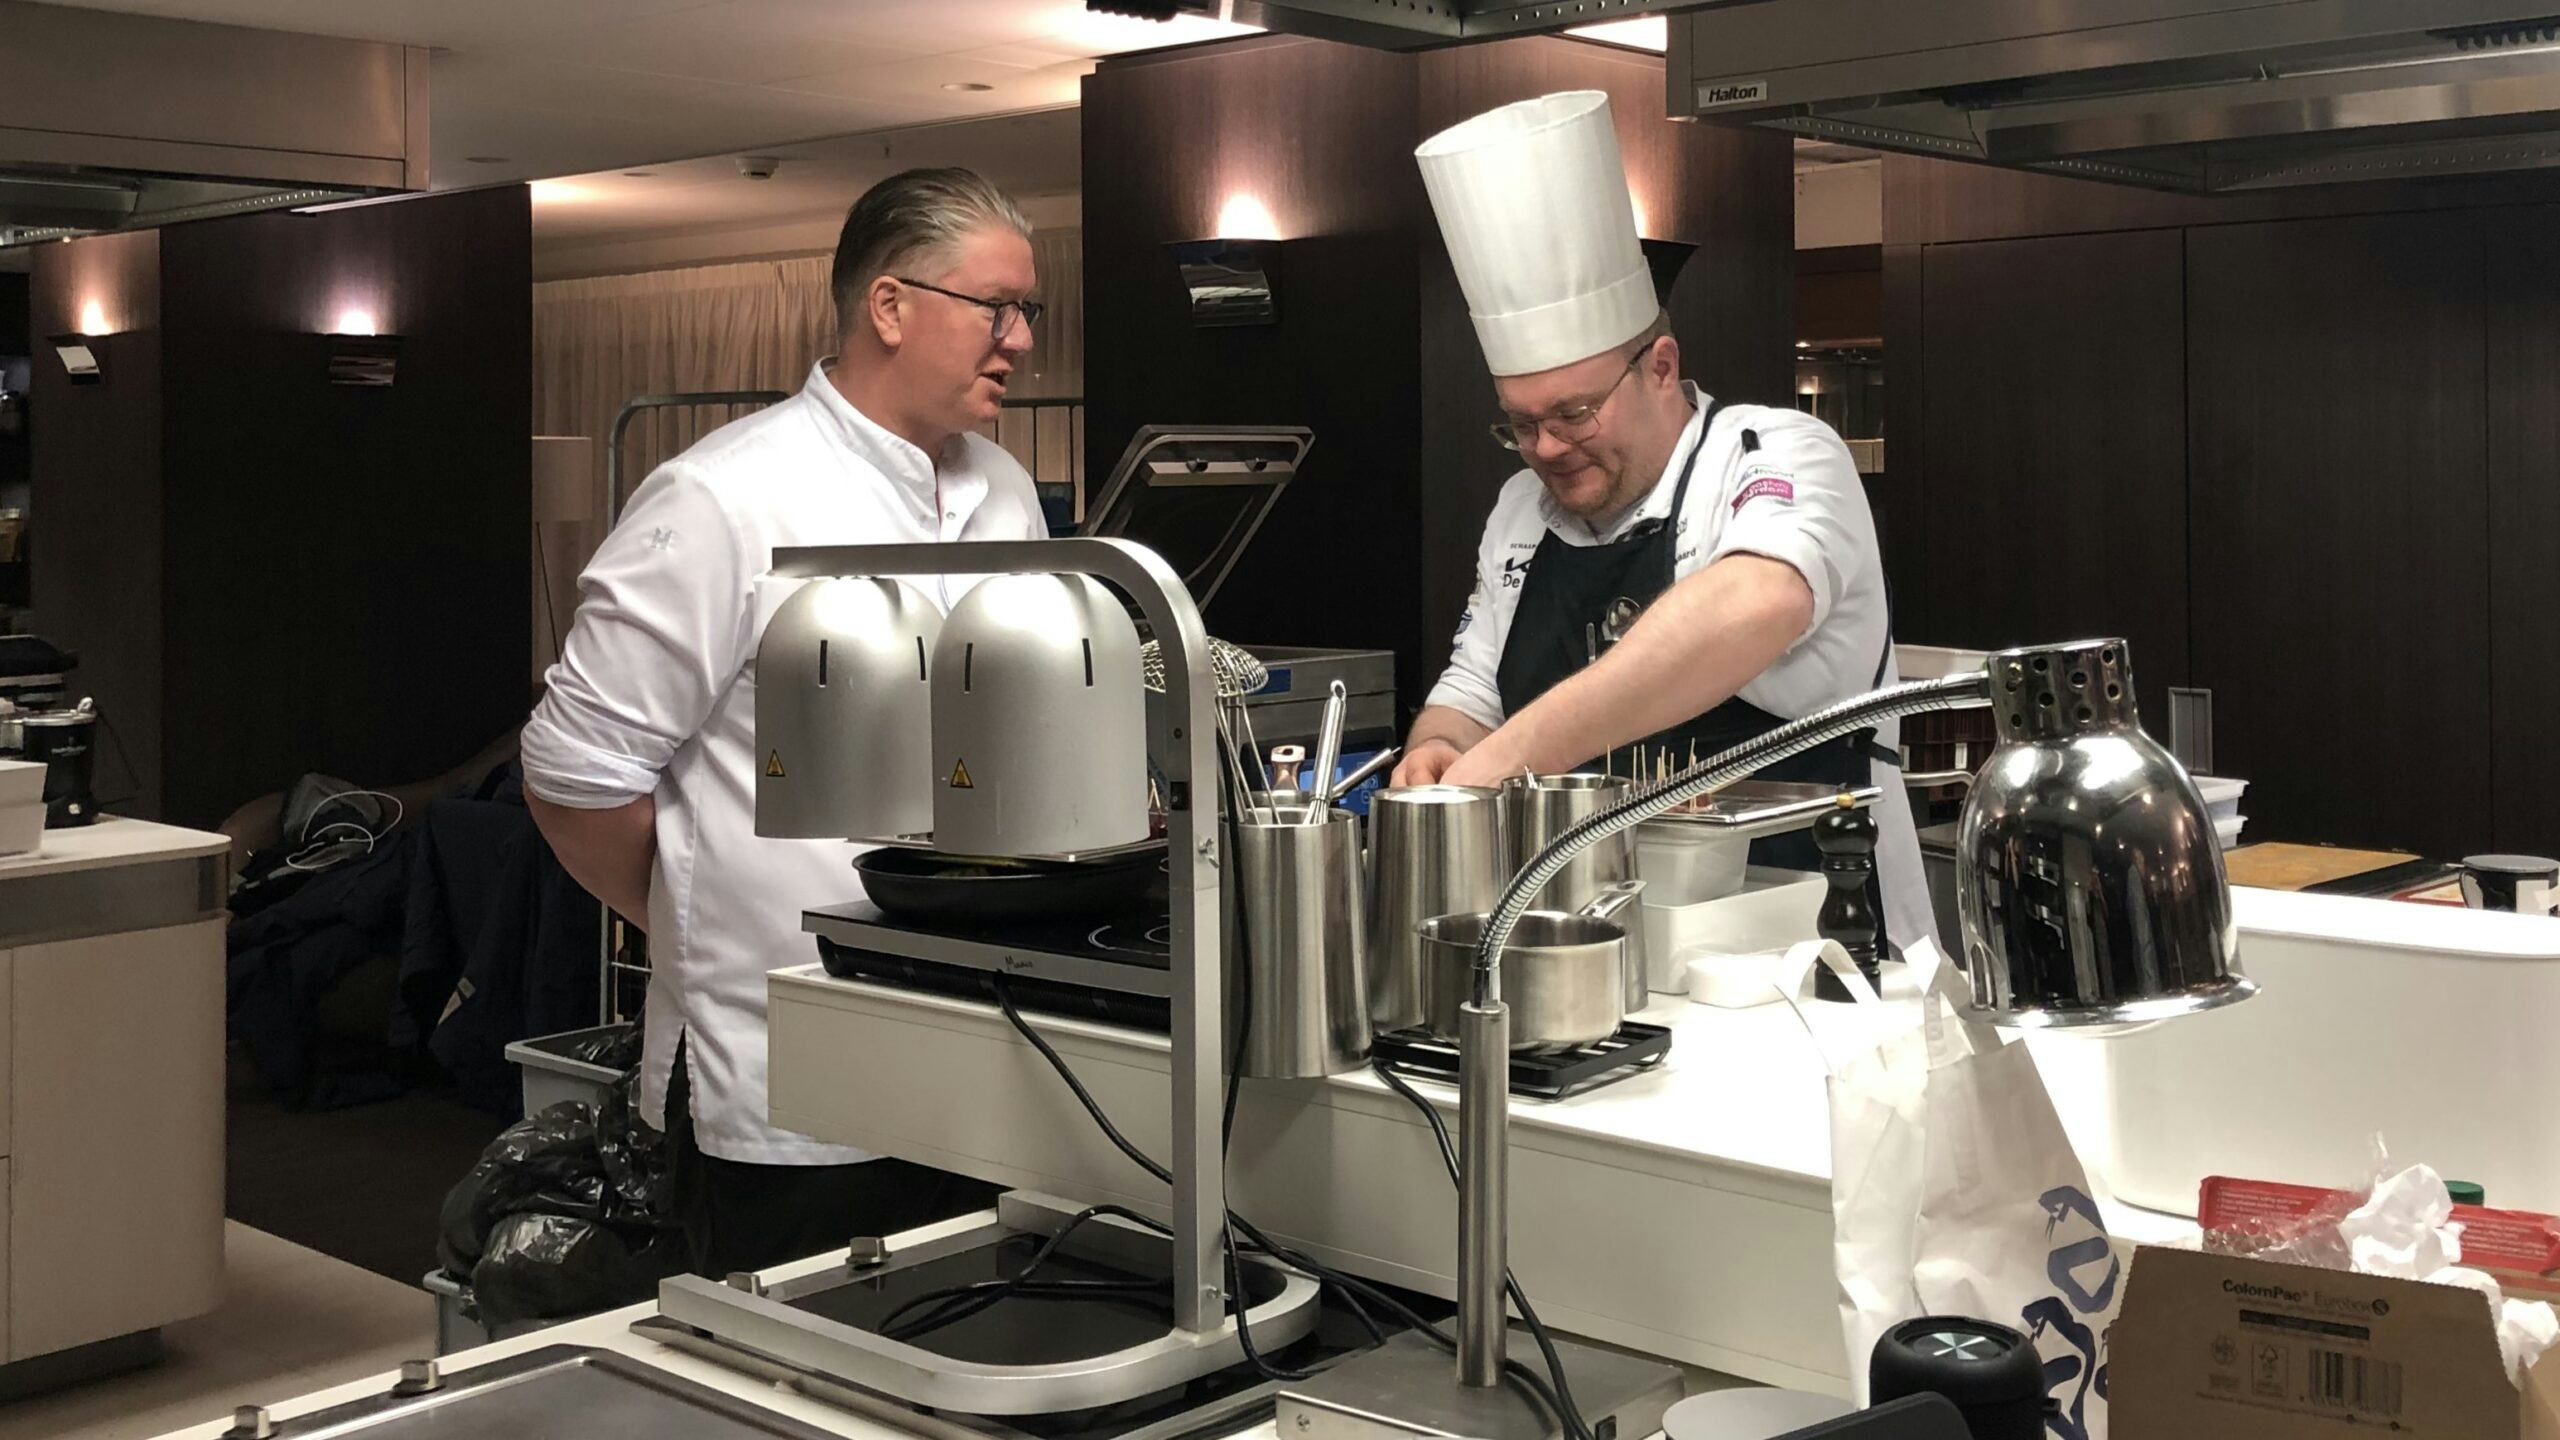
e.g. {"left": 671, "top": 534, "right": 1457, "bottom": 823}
{"left": 1395, "top": 90, "right": 1933, "bottom": 945}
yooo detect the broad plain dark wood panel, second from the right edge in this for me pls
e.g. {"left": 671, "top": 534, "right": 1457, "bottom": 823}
{"left": 2181, "top": 215, "right": 2491, "bottom": 856}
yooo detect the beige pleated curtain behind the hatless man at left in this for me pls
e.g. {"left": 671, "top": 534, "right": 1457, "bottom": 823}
{"left": 532, "top": 231, "right": 1085, "bottom": 671}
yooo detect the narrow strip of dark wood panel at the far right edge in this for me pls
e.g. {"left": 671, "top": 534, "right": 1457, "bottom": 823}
{"left": 2478, "top": 205, "right": 2560, "bottom": 856}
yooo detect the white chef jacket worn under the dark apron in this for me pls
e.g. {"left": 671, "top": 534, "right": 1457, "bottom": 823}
{"left": 1426, "top": 384, "right": 1935, "bottom": 945}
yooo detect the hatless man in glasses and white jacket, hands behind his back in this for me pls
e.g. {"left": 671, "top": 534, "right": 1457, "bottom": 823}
{"left": 525, "top": 169, "right": 1047, "bottom": 1276}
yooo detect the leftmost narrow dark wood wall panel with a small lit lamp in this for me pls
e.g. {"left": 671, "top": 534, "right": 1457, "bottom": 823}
{"left": 28, "top": 231, "right": 162, "bottom": 817}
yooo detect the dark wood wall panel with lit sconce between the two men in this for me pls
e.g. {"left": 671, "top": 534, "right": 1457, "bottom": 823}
{"left": 1083, "top": 38, "right": 1436, "bottom": 692}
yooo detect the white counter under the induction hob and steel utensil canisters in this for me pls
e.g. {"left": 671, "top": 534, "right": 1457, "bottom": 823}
{"left": 771, "top": 966, "right": 2191, "bottom": 1391}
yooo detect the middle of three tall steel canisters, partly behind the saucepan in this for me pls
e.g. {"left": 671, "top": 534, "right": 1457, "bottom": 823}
{"left": 1367, "top": 784, "right": 1510, "bottom": 1035}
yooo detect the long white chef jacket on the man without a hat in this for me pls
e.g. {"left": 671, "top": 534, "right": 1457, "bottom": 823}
{"left": 525, "top": 361, "right": 1047, "bottom": 1166}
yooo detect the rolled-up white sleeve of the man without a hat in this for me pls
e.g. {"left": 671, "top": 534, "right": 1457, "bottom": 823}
{"left": 522, "top": 464, "right": 755, "bottom": 810}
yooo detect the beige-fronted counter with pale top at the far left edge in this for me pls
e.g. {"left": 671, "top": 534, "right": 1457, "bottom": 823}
{"left": 0, "top": 817, "right": 230, "bottom": 1368}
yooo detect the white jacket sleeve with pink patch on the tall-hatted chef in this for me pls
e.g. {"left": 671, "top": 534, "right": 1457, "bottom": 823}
{"left": 1705, "top": 418, "right": 1874, "bottom": 641}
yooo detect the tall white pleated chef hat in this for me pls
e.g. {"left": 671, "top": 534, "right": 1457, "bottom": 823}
{"left": 1413, "top": 90, "right": 1661, "bottom": 374}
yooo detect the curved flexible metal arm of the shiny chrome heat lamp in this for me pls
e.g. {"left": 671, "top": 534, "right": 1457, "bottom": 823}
{"left": 1472, "top": 669, "right": 1992, "bottom": 1004}
